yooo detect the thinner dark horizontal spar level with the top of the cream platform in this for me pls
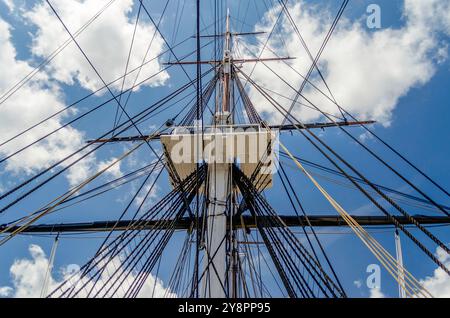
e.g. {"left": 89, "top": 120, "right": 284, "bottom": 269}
{"left": 87, "top": 121, "right": 376, "bottom": 143}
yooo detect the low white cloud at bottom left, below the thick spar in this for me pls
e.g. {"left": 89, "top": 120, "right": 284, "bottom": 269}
{"left": 0, "top": 244, "right": 176, "bottom": 298}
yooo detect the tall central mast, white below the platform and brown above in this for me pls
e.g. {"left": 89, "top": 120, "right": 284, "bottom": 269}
{"left": 201, "top": 11, "right": 232, "bottom": 298}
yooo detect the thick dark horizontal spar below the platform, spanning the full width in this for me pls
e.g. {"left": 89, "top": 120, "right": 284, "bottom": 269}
{"left": 0, "top": 215, "right": 450, "bottom": 233}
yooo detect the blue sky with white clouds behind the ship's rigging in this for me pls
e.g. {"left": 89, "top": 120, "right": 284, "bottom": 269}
{"left": 0, "top": 0, "right": 450, "bottom": 297}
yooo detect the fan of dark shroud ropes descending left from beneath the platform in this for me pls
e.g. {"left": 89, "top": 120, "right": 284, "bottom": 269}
{"left": 50, "top": 165, "right": 207, "bottom": 297}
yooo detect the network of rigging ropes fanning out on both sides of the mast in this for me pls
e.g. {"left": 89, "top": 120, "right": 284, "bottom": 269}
{"left": 0, "top": 0, "right": 450, "bottom": 297}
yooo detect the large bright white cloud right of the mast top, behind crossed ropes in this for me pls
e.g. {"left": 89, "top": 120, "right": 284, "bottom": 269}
{"left": 241, "top": 0, "right": 450, "bottom": 125}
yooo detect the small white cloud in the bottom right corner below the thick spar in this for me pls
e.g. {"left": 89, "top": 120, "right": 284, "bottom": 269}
{"left": 420, "top": 248, "right": 450, "bottom": 298}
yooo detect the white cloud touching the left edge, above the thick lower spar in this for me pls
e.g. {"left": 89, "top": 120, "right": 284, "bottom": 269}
{"left": 0, "top": 14, "right": 126, "bottom": 191}
